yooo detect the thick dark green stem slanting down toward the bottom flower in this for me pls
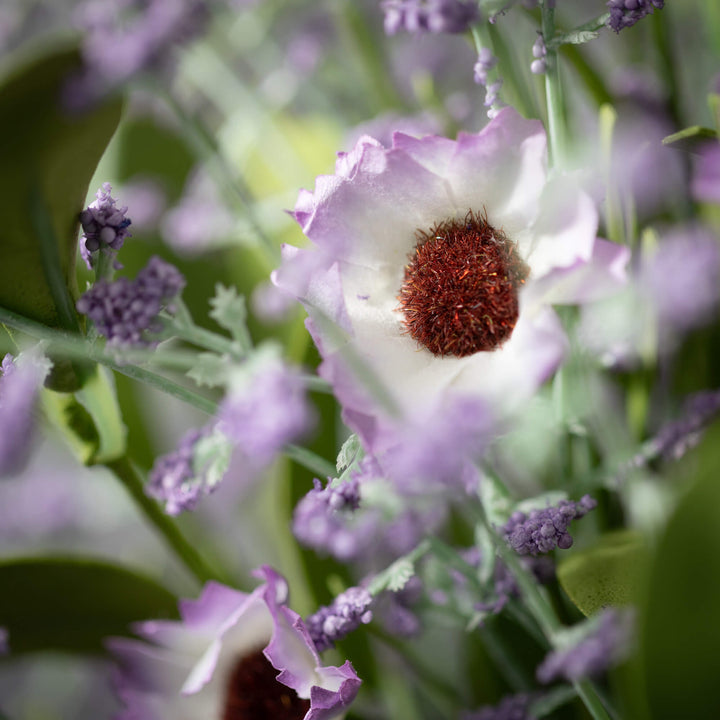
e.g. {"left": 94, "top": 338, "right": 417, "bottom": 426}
{"left": 104, "top": 457, "right": 227, "bottom": 585}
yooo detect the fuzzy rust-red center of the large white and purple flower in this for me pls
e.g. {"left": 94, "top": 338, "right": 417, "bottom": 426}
{"left": 398, "top": 211, "right": 530, "bottom": 357}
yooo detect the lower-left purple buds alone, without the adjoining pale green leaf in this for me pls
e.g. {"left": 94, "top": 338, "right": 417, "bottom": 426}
{"left": 147, "top": 426, "right": 213, "bottom": 515}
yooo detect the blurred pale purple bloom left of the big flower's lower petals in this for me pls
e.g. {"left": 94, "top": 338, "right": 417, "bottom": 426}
{"left": 217, "top": 349, "right": 315, "bottom": 468}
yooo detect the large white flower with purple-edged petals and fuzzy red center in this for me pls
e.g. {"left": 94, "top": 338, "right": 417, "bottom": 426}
{"left": 274, "top": 108, "right": 628, "bottom": 466}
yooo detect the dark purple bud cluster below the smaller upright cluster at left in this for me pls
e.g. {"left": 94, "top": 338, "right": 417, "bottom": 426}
{"left": 77, "top": 256, "right": 185, "bottom": 346}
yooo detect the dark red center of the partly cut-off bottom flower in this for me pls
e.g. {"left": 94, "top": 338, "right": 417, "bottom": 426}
{"left": 222, "top": 649, "right": 310, "bottom": 720}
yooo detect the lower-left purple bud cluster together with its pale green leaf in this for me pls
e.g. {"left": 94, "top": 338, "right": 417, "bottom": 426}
{"left": 147, "top": 425, "right": 231, "bottom": 515}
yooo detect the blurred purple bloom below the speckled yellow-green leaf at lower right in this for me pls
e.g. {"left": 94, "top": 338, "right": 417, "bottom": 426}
{"left": 536, "top": 608, "right": 635, "bottom": 683}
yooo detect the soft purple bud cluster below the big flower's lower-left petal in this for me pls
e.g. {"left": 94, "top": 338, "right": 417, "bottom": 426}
{"left": 293, "top": 476, "right": 360, "bottom": 560}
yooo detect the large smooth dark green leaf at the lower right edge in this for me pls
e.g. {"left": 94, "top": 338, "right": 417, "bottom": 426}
{"left": 640, "top": 425, "right": 720, "bottom": 720}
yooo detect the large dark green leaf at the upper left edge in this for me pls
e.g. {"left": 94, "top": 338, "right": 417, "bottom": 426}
{"left": 0, "top": 47, "right": 121, "bottom": 389}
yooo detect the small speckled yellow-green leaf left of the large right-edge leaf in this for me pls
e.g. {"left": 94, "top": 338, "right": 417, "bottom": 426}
{"left": 557, "top": 530, "right": 647, "bottom": 615}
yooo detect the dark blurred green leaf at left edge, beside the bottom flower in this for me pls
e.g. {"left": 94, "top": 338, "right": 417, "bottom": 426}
{"left": 0, "top": 557, "right": 178, "bottom": 655}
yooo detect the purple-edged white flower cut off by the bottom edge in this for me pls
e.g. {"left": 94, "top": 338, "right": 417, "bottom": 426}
{"left": 108, "top": 566, "right": 361, "bottom": 720}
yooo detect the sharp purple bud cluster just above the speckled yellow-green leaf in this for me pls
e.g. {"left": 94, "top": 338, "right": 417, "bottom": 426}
{"left": 501, "top": 495, "right": 597, "bottom": 555}
